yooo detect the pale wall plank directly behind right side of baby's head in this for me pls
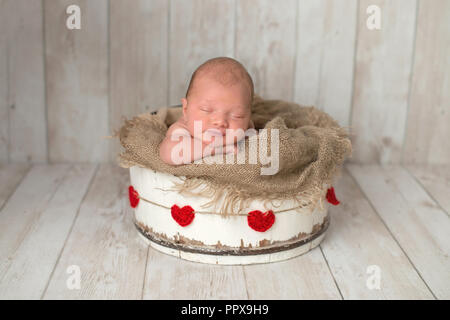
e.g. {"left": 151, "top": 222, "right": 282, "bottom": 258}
{"left": 235, "top": 0, "right": 296, "bottom": 100}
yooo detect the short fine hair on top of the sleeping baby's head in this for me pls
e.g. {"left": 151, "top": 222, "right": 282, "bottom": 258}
{"left": 186, "top": 57, "right": 254, "bottom": 101}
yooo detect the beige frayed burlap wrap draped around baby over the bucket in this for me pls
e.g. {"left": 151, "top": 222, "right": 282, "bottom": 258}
{"left": 118, "top": 96, "right": 352, "bottom": 215}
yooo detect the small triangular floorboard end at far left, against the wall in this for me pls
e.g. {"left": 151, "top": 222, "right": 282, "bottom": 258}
{"left": 0, "top": 164, "right": 29, "bottom": 210}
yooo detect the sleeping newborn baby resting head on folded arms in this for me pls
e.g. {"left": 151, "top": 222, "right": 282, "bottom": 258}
{"left": 159, "top": 57, "right": 254, "bottom": 165}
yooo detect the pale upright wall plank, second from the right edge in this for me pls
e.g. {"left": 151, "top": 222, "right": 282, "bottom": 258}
{"left": 351, "top": 0, "right": 416, "bottom": 163}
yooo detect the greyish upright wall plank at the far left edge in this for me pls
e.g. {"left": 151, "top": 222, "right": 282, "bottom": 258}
{"left": 0, "top": 0, "right": 47, "bottom": 162}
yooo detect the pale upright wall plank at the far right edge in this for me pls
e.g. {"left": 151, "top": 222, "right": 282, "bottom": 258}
{"left": 402, "top": 0, "right": 450, "bottom": 164}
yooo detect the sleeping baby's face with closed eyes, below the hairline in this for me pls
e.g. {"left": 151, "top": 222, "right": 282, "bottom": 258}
{"left": 182, "top": 77, "right": 251, "bottom": 139}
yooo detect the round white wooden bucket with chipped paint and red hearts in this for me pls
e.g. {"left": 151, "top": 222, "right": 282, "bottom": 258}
{"left": 129, "top": 166, "right": 329, "bottom": 265}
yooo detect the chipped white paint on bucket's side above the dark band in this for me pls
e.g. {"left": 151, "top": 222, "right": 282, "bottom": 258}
{"left": 130, "top": 166, "right": 329, "bottom": 248}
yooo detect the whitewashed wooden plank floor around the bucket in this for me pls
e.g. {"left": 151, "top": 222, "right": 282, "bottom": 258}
{"left": 0, "top": 164, "right": 450, "bottom": 299}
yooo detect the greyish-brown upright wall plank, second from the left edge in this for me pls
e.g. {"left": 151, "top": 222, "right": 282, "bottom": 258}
{"left": 44, "top": 0, "right": 110, "bottom": 162}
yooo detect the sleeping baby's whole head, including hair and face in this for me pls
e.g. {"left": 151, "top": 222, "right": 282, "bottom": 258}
{"left": 181, "top": 57, "right": 254, "bottom": 135}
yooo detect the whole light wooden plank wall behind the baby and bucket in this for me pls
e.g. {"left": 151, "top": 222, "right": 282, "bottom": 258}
{"left": 0, "top": 0, "right": 450, "bottom": 164}
